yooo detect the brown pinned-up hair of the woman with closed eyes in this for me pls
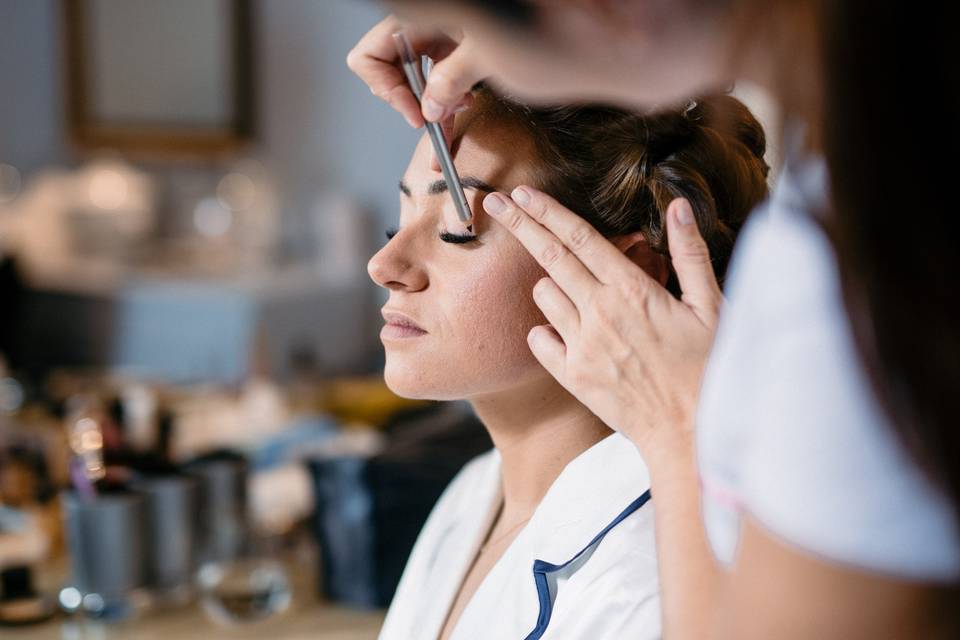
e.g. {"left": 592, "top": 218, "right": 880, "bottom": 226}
{"left": 462, "top": 86, "right": 769, "bottom": 295}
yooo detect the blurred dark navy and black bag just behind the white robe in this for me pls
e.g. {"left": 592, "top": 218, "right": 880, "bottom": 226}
{"left": 309, "top": 403, "right": 493, "bottom": 608}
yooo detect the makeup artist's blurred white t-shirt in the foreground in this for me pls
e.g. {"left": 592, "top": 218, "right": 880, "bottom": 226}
{"left": 697, "top": 148, "right": 960, "bottom": 581}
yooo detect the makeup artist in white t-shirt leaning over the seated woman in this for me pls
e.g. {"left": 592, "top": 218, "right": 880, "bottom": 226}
{"left": 348, "top": 5, "right": 960, "bottom": 640}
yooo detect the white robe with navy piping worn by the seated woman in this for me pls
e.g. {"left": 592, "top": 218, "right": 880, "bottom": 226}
{"left": 380, "top": 434, "right": 660, "bottom": 640}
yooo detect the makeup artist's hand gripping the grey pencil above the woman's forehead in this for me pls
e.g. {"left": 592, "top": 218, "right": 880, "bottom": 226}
{"left": 347, "top": 16, "right": 485, "bottom": 127}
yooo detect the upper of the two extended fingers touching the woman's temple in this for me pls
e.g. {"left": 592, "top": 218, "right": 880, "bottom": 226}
{"left": 510, "top": 185, "right": 643, "bottom": 284}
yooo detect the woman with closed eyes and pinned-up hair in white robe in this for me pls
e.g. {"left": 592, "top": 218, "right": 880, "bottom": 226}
{"left": 369, "top": 88, "right": 767, "bottom": 640}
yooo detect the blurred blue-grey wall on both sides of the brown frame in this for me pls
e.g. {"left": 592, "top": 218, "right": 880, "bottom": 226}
{"left": 0, "top": 0, "right": 417, "bottom": 237}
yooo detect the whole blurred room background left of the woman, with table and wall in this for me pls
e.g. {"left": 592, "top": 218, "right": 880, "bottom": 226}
{"left": 0, "top": 0, "right": 490, "bottom": 639}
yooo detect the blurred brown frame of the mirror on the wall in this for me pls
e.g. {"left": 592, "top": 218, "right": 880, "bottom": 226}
{"left": 62, "top": 0, "right": 255, "bottom": 158}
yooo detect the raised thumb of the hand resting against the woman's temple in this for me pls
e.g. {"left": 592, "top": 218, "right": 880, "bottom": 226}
{"left": 667, "top": 198, "right": 723, "bottom": 326}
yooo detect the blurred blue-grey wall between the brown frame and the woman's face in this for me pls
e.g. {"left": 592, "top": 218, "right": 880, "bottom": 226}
{"left": 258, "top": 0, "right": 418, "bottom": 227}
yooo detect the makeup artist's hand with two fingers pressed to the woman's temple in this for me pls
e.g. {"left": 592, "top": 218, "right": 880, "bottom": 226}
{"left": 484, "top": 187, "right": 723, "bottom": 455}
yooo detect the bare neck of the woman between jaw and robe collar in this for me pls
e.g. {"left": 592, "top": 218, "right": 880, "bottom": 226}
{"left": 470, "top": 377, "right": 613, "bottom": 524}
